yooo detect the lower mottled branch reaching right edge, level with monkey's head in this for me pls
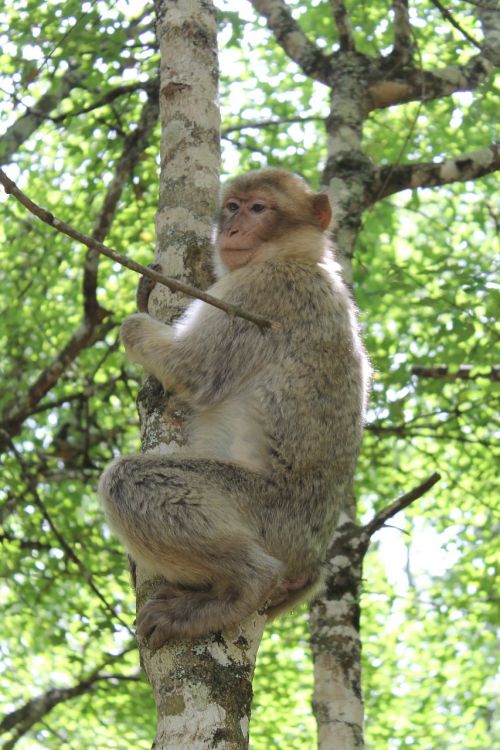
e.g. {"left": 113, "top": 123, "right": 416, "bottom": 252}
{"left": 370, "top": 143, "right": 500, "bottom": 203}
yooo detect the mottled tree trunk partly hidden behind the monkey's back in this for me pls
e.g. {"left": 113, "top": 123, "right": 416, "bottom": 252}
{"left": 310, "top": 50, "right": 373, "bottom": 750}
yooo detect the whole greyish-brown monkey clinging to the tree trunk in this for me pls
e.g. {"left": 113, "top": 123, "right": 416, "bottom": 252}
{"left": 99, "top": 169, "right": 369, "bottom": 649}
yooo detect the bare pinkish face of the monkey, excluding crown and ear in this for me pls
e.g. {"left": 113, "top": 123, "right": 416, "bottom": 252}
{"left": 219, "top": 191, "right": 278, "bottom": 270}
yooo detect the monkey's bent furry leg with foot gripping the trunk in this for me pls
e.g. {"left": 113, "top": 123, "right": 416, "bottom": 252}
{"left": 99, "top": 454, "right": 283, "bottom": 649}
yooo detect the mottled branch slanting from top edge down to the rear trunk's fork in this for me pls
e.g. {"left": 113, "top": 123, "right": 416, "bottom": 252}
{"left": 250, "top": 0, "right": 331, "bottom": 84}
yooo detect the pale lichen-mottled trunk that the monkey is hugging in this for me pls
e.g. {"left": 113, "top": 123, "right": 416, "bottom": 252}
{"left": 136, "top": 0, "right": 265, "bottom": 750}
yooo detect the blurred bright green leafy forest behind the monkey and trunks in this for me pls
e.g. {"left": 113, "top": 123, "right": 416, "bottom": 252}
{"left": 0, "top": 0, "right": 499, "bottom": 750}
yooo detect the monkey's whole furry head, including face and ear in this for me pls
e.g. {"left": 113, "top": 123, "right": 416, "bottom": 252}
{"left": 217, "top": 169, "right": 332, "bottom": 271}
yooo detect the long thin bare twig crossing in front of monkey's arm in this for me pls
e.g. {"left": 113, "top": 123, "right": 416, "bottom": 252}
{"left": 0, "top": 169, "right": 281, "bottom": 331}
